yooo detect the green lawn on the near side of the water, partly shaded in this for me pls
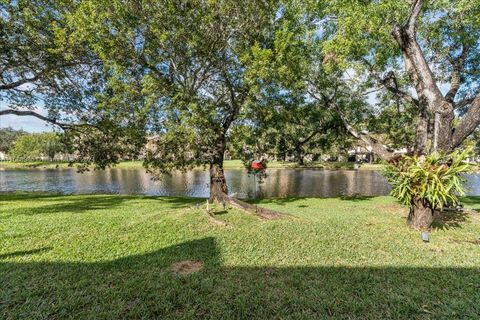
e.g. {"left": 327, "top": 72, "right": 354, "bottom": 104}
{"left": 0, "top": 194, "right": 480, "bottom": 319}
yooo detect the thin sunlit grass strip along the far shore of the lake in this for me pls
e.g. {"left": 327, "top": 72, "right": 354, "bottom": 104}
{"left": 0, "top": 160, "right": 381, "bottom": 170}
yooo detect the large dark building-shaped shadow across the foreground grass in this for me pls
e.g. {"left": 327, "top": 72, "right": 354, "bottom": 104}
{"left": 0, "top": 238, "right": 480, "bottom": 319}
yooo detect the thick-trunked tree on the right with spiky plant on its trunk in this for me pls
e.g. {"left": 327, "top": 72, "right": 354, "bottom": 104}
{"left": 321, "top": 0, "right": 480, "bottom": 229}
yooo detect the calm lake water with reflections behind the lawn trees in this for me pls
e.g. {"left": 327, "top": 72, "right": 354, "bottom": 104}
{"left": 0, "top": 169, "right": 480, "bottom": 198}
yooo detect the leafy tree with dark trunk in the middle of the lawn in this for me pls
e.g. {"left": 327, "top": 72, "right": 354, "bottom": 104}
{"left": 72, "top": 1, "right": 282, "bottom": 202}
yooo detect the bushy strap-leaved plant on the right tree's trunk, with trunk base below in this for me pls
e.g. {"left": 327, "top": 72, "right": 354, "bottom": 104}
{"left": 383, "top": 148, "right": 473, "bottom": 229}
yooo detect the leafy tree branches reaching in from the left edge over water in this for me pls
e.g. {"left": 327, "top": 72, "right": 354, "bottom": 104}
{"left": 0, "top": 0, "right": 145, "bottom": 168}
